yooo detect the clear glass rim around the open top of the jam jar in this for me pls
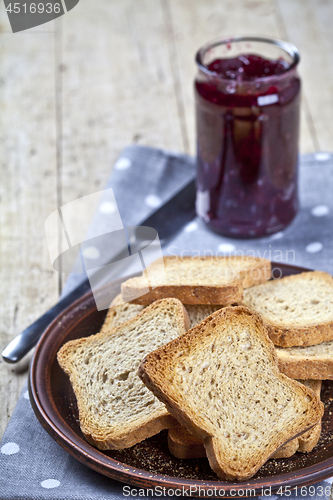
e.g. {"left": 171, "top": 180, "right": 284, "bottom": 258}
{"left": 195, "top": 35, "right": 300, "bottom": 82}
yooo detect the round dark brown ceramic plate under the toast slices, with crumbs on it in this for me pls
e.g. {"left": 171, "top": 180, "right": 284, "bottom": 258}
{"left": 29, "top": 264, "right": 333, "bottom": 498}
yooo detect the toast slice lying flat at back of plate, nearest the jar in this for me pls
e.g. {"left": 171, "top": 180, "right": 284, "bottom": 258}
{"left": 121, "top": 256, "right": 271, "bottom": 305}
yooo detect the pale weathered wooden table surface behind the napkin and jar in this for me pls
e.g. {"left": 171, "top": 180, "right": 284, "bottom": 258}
{"left": 0, "top": 0, "right": 333, "bottom": 437}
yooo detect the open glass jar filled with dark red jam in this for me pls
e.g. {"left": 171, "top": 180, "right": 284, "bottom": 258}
{"left": 195, "top": 37, "right": 301, "bottom": 238}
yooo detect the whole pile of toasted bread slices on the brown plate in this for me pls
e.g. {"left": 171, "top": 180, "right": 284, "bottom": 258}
{"left": 58, "top": 257, "right": 333, "bottom": 480}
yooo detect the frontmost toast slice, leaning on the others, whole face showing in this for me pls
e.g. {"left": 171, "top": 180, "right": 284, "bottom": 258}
{"left": 139, "top": 307, "right": 323, "bottom": 480}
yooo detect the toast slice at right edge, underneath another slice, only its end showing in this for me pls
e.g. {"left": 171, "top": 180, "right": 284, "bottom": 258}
{"left": 276, "top": 340, "right": 333, "bottom": 380}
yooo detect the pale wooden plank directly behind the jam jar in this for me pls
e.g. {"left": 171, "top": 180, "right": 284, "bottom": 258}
{"left": 169, "top": 0, "right": 315, "bottom": 154}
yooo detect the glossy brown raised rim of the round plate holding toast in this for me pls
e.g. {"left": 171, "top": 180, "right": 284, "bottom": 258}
{"left": 28, "top": 262, "right": 333, "bottom": 498}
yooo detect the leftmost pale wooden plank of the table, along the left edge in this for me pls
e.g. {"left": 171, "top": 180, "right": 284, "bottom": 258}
{"left": 0, "top": 2, "right": 58, "bottom": 437}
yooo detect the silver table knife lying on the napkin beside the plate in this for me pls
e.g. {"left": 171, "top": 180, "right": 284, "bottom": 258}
{"left": 2, "top": 179, "right": 196, "bottom": 363}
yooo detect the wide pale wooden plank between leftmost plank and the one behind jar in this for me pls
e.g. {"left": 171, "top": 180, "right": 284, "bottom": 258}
{"left": 61, "top": 0, "right": 185, "bottom": 208}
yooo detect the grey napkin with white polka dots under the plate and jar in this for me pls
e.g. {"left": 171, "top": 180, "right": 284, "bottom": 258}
{"left": 0, "top": 146, "right": 333, "bottom": 500}
